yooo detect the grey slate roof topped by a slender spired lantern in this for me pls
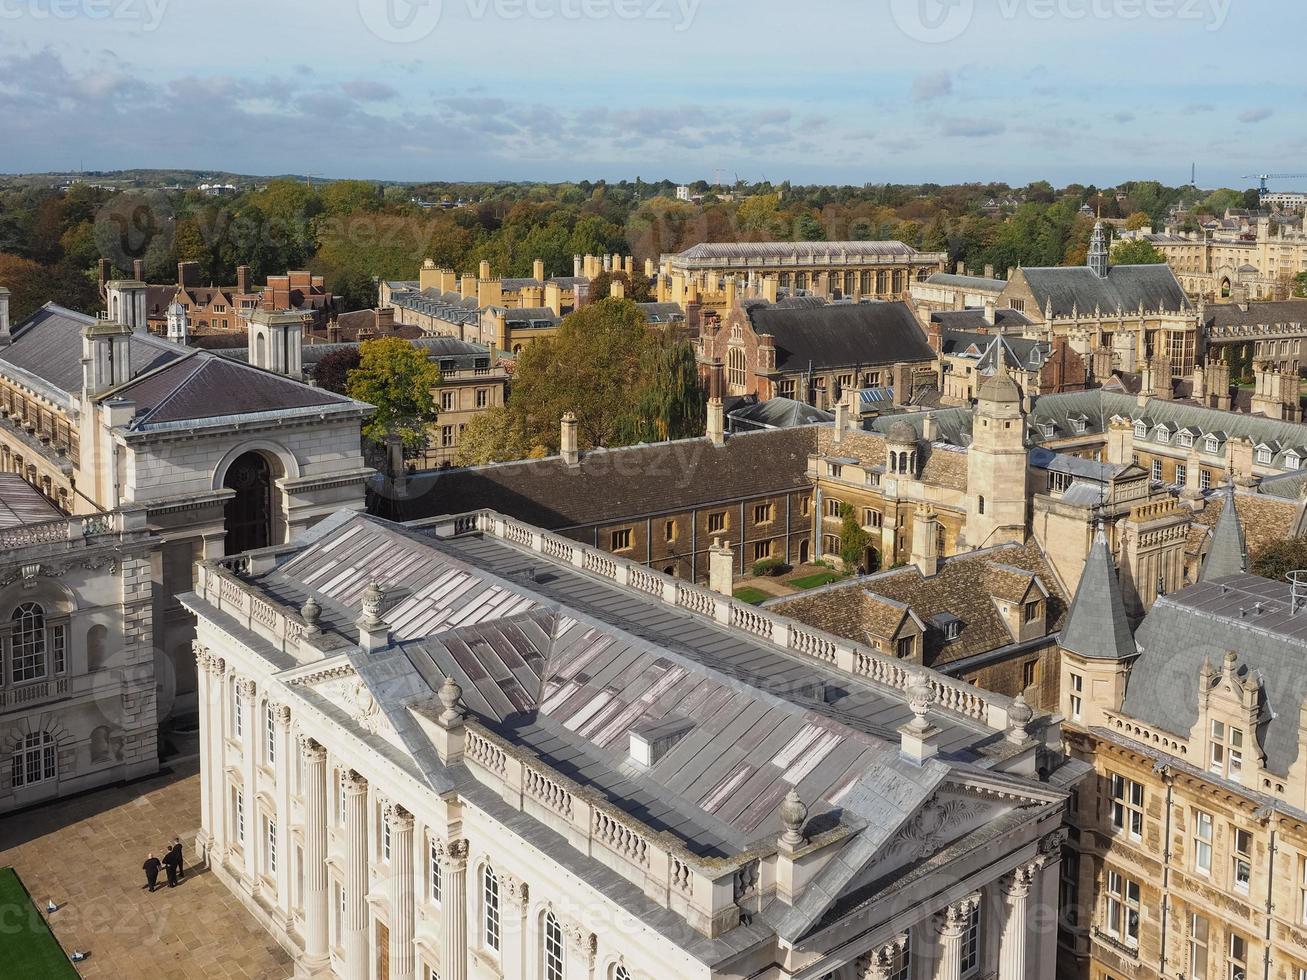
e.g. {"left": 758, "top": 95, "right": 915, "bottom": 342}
{"left": 1017, "top": 264, "right": 1189, "bottom": 316}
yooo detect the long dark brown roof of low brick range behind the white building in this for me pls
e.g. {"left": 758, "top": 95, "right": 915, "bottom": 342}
{"left": 370, "top": 426, "right": 817, "bottom": 531}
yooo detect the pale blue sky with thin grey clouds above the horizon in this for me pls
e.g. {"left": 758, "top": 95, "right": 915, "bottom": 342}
{"left": 0, "top": 0, "right": 1307, "bottom": 189}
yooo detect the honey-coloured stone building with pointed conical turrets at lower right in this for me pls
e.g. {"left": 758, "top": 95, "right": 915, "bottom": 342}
{"left": 1059, "top": 498, "right": 1307, "bottom": 980}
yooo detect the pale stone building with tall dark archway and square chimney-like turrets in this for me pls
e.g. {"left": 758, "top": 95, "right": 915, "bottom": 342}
{"left": 0, "top": 291, "right": 371, "bottom": 711}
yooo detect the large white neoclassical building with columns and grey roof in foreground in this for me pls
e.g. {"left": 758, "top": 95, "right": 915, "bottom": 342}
{"left": 186, "top": 511, "right": 1084, "bottom": 980}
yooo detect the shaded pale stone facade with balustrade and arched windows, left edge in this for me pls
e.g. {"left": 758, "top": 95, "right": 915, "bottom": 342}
{"left": 0, "top": 472, "right": 157, "bottom": 813}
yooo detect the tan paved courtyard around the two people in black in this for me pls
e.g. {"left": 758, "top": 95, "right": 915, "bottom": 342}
{"left": 0, "top": 762, "right": 293, "bottom": 980}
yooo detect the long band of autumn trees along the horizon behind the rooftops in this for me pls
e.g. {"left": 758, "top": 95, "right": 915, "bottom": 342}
{"left": 0, "top": 172, "right": 1257, "bottom": 316}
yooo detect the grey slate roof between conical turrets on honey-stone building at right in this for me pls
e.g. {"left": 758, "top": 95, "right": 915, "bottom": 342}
{"left": 1121, "top": 575, "right": 1307, "bottom": 776}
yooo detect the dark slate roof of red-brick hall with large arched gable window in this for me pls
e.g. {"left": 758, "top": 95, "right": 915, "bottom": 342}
{"left": 748, "top": 303, "right": 935, "bottom": 372}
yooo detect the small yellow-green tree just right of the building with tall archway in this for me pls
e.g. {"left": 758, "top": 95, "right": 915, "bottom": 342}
{"left": 348, "top": 337, "right": 440, "bottom": 449}
